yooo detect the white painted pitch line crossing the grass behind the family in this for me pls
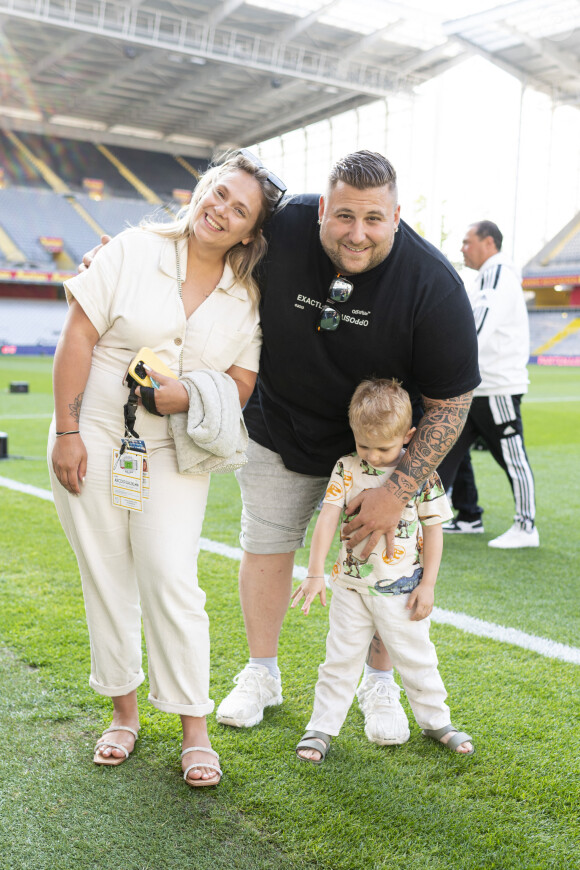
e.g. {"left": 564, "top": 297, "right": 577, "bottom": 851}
{"left": 0, "top": 477, "right": 580, "bottom": 665}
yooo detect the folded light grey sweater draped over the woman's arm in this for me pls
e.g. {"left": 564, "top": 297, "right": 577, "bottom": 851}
{"left": 169, "top": 369, "right": 248, "bottom": 474}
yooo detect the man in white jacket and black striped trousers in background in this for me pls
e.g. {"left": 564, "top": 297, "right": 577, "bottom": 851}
{"left": 438, "top": 221, "right": 540, "bottom": 550}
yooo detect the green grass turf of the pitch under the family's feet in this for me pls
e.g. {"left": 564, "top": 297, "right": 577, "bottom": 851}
{"left": 0, "top": 358, "right": 580, "bottom": 870}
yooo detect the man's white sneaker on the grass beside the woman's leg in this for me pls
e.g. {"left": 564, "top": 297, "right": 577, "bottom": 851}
{"left": 216, "top": 665, "right": 283, "bottom": 728}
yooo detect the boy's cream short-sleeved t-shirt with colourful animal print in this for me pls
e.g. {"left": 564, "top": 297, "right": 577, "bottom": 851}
{"left": 324, "top": 453, "right": 453, "bottom": 595}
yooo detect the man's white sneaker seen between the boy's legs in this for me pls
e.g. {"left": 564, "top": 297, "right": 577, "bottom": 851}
{"left": 356, "top": 676, "right": 410, "bottom": 746}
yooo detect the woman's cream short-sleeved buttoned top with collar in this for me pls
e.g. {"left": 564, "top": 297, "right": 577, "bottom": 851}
{"left": 65, "top": 229, "right": 262, "bottom": 377}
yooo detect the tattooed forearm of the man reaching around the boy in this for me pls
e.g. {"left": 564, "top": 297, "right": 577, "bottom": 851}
{"left": 391, "top": 393, "right": 472, "bottom": 486}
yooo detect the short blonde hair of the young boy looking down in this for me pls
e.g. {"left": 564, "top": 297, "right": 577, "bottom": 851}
{"left": 348, "top": 378, "right": 413, "bottom": 438}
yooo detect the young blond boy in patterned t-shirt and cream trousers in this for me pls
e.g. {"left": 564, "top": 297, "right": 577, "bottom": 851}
{"left": 292, "top": 379, "right": 474, "bottom": 764}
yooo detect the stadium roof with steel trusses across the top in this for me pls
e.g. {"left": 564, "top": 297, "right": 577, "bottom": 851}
{"left": 0, "top": 0, "right": 580, "bottom": 157}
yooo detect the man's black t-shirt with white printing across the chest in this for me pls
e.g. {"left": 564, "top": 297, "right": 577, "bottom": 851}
{"left": 244, "top": 194, "right": 480, "bottom": 475}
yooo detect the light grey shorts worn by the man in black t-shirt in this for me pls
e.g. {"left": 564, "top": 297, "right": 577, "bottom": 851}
{"left": 236, "top": 441, "right": 328, "bottom": 555}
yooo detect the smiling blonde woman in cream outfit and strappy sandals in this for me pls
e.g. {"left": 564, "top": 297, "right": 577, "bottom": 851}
{"left": 49, "top": 151, "right": 285, "bottom": 786}
